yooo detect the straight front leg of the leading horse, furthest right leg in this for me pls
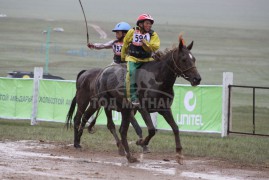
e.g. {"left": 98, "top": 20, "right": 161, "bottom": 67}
{"left": 159, "top": 109, "right": 183, "bottom": 164}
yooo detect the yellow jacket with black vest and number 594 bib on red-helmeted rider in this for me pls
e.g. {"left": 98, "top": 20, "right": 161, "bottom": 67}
{"left": 121, "top": 27, "right": 160, "bottom": 62}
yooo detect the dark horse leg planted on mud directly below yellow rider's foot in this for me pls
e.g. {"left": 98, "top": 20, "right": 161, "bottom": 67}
{"left": 120, "top": 110, "right": 138, "bottom": 163}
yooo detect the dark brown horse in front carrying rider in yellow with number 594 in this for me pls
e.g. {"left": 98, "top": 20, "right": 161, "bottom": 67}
{"left": 74, "top": 38, "right": 201, "bottom": 164}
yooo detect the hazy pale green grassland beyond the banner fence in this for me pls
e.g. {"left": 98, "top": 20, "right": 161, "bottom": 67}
{"left": 0, "top": 18, "right": 269, "bottom": 86}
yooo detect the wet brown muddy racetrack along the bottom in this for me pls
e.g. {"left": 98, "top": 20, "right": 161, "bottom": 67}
{"left": 0, "top": 141, "right": 269, "bottom": 180}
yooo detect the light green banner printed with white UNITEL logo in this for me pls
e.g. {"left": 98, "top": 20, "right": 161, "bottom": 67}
{"left": 110, "top": 85, "right": 222, "bottom": 133}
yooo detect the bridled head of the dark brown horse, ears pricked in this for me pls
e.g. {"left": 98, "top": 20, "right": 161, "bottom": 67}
{"left": 172, "top": 36, "right": 201, "bottom": 86}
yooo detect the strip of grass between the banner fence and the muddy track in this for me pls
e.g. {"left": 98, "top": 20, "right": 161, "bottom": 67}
{"left": 0, "top": 120, "right": 269, "bottom": 167}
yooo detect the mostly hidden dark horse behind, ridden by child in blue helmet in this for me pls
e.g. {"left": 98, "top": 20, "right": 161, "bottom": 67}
{"left": 66, "top": 65, "right": 149, "bottom": 155}
